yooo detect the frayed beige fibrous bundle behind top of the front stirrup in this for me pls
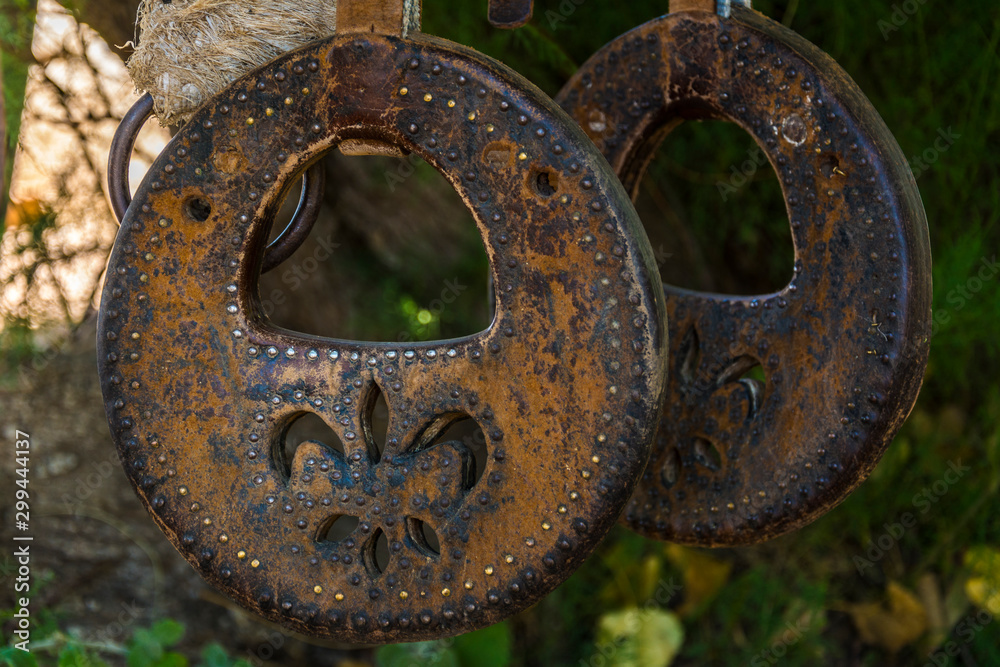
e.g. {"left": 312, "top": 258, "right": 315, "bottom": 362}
{"left": 128, "top": 0, "right": 337, "bottom": 125}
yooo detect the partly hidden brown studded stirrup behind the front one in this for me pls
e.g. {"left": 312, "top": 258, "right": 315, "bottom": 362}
{"left": 558, "top": 5, "right": 931, "bottom": 546}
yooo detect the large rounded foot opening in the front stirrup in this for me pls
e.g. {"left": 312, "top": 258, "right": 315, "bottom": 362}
{"left": 257, "top": 152, "right": 492, "bottom": 343}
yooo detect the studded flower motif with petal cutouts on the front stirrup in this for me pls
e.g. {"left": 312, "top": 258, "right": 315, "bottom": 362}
{"left": 289, "top": 383, "right": 476, "bottom": 579}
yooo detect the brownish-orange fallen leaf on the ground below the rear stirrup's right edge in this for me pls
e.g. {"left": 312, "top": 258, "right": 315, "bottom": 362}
{"left": 848, "top": 581, "right": 927, "bottom": 653}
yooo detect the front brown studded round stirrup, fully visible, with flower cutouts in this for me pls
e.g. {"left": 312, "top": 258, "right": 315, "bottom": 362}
{"left": 99, "top": 0, "right": 666, "bottom": 643}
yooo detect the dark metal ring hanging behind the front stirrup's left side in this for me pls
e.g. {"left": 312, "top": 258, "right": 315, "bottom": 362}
{"left": 108, "top": 93, "right": 326, "bottom": 273}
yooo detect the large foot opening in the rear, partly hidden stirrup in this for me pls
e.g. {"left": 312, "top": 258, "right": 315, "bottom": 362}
{"left": 635, "top": 120, "right": 792, "bottom": 295}
